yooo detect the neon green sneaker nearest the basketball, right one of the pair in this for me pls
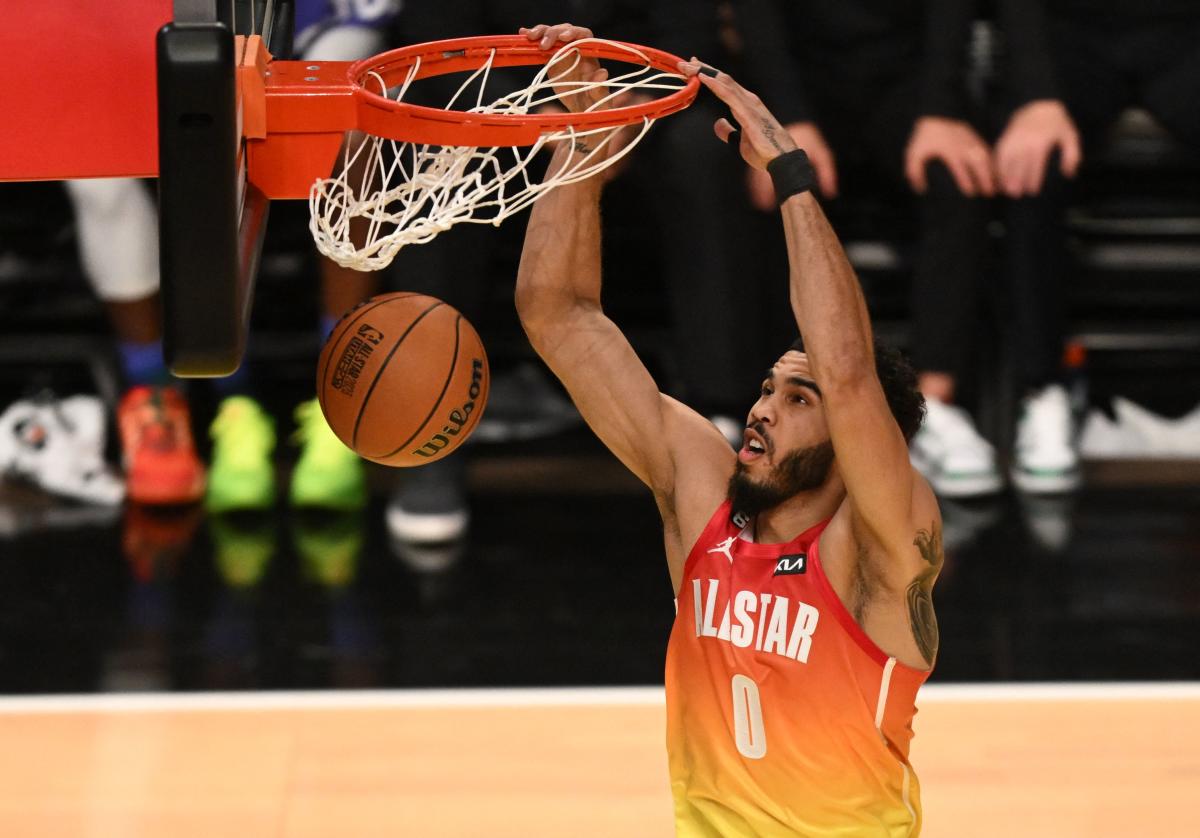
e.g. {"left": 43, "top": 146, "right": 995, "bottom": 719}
{"left": 289, "top": 399, "right": 367, "bottom": 509}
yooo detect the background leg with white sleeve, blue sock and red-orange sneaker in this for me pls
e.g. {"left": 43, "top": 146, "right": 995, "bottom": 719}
{"left": 66, "top": 179, "right": 205, "bottom": 504}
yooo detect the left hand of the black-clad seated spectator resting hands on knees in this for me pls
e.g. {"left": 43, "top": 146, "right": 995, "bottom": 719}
{"left": 904, "top": 116, "right": 996, "bottom": 198}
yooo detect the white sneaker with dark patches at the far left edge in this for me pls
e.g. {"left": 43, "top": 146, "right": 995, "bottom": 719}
{"left": 0, "top": 396, "right": 125, "bottom": 505}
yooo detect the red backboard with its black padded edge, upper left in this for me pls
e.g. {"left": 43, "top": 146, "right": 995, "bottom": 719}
{"left": 0, "top": 0, "right": 294, "bottom": 376}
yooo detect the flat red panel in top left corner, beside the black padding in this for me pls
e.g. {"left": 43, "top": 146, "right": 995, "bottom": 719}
{"left": 0, "top": 0, "right": 173, "bottom": 180}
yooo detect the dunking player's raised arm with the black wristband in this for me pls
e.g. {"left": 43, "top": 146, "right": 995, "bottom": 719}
{"left": 682, "top": 60, "right": 936, "bottom": 561}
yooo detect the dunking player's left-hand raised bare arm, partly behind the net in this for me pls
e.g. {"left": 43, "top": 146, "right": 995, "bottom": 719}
{"left": 516, "top": 24, "right": 733, "bottom": 511}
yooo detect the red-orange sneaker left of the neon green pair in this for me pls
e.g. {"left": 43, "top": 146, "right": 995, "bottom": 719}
{"left": 116, "top": 387, "right": 204, "bottom": 505}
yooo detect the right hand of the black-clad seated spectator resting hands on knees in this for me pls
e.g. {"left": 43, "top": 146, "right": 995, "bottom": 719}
{"left": 994, "top": 100, "right": 1082, "bottom": 198}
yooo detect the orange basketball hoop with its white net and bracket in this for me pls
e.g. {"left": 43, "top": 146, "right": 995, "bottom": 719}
{"left": 244, "top": 36, "right": 700, "bottom": 270}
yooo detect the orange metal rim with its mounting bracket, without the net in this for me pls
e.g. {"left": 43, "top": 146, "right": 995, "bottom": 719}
{"left": 248, "top": 35, "right": 700, "bottom": 200}
